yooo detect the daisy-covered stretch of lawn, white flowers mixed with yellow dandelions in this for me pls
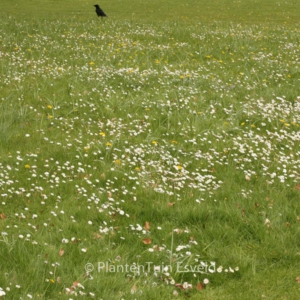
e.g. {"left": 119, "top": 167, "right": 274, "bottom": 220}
{"left": 0, "top": 17, "right": 300, "bottom": 298}
